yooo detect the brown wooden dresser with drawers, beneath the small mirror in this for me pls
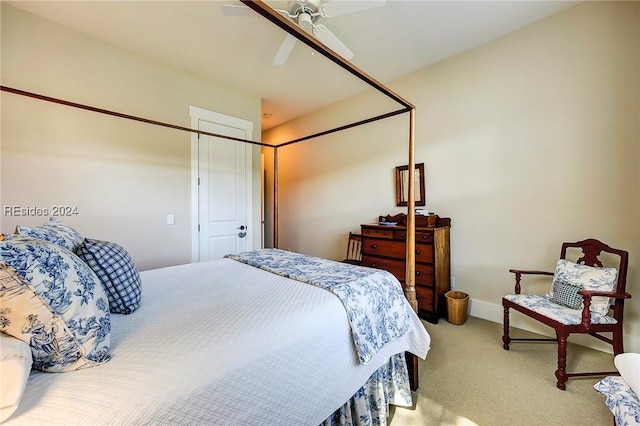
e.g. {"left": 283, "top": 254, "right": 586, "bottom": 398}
{"left": 360, "top": 215, "right": 451, "bottom": 323}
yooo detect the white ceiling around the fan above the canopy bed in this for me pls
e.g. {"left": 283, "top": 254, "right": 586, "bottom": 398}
{"left": 3, "top": 0, "right": 579, "bottom": 129}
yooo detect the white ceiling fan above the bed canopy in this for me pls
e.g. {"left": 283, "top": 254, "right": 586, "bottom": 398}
{"left": 223, "top": 0, "right": 386, "bottom": 65}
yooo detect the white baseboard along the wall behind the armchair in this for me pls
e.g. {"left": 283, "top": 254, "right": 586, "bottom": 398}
{"left": 469, "top": 299, "right": 640, "bottom": 353}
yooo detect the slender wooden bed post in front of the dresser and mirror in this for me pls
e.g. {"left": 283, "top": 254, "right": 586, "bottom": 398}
{"left": 405, "top": 108, "right": 418, "bottom": 313}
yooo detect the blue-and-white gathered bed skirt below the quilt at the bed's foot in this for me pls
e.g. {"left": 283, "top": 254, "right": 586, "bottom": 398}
{"left": 322, "top": 353, "right": 413, "bottom": 426}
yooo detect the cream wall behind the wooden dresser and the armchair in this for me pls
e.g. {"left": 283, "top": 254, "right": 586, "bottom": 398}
{"left": 263, "top": 2, "right": 640, "bottom": 351}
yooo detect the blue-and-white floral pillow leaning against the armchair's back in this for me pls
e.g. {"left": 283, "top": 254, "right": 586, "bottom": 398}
{"left": 549, "top": 259, "right": 618, "bottom": 315}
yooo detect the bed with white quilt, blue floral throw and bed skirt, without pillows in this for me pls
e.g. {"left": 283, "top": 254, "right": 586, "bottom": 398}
{"left": 0, "top": 230, "right": 430, "bottom": 425}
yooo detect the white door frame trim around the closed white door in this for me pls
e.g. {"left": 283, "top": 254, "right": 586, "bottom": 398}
{"left": 189, "top": 106, "right": 253, "bottom": 262}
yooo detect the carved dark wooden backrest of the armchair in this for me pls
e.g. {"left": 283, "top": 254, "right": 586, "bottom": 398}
{"left": 560, "top": 239, "right": 629, "bottom": 320}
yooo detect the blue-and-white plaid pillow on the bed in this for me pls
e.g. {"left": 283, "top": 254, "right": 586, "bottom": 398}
{"left": 78, "top": 238, "right": 142, "bottom": 314}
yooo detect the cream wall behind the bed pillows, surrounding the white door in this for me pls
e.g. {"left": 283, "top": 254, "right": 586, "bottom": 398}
{"left": 0, "top": 4, "right": 261, "bottom": 269}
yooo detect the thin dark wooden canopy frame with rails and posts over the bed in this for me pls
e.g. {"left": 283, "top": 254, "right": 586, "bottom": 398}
{"left": 0, "top": 0, "right": 418, "bottom": 312}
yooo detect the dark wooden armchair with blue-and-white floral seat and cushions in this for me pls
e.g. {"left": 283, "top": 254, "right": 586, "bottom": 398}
{"left": 502, "top": 239, "right": 631, "bottom": 390}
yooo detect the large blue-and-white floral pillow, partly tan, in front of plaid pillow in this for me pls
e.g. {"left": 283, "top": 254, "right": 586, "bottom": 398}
{"left": 0, "top": 237, "right": 111, "bottom": 372}
